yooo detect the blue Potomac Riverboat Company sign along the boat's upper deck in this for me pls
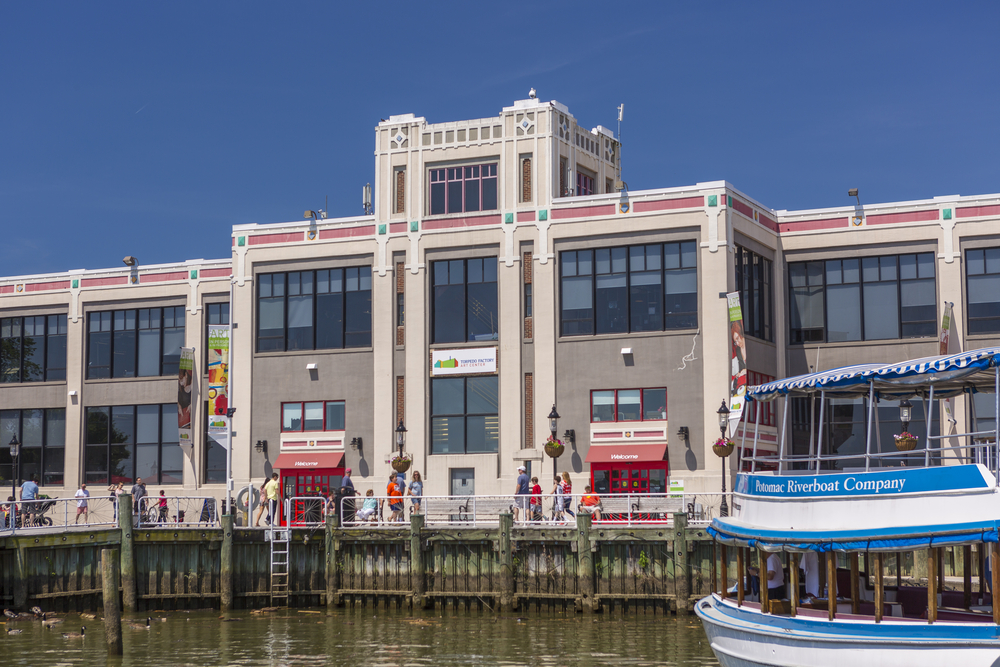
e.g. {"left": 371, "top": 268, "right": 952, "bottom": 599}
{"left": 736, "top": 465, "right": 992, "bottom": 500}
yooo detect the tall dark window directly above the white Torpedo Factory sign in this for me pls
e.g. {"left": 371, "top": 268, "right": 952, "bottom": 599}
{"left": 431, "top": 257, "right": 499, "bottom": 343}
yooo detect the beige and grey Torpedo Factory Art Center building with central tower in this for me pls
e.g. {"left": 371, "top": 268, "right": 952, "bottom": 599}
{"left": 0, "top": 99, "right": 1000, "bottom": 504}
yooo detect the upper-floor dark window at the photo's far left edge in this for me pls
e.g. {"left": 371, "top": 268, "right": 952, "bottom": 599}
{"left": 0, "top": 315, "right": 66, "bottom": 382}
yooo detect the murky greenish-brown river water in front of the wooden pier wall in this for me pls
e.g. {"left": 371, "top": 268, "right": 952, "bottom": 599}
{"left": 0, "top": 609, "right": 719, "bottom": 667}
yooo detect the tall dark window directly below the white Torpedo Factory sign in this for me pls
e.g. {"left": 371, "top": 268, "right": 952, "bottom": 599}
{"left": 431, "top": 375, "right": 500, "bottom": 454}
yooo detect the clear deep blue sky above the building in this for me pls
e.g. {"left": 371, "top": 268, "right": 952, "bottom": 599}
{"left": 0, "top": 0, "right": 1000, "bottom": 276}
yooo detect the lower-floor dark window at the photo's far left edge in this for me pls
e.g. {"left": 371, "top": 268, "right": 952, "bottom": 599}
{"left": 0, "top": 408, "right": 66, "bottom": 486}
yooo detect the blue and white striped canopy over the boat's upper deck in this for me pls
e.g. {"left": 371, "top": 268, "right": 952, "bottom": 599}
{"left": 747, "top": 347, "right": 1000, "bottom": 402}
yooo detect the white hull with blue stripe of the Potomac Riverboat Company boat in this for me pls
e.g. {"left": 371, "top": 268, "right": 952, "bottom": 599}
{"left": 695, "top": 596, "right": 1000, "bottom": 667}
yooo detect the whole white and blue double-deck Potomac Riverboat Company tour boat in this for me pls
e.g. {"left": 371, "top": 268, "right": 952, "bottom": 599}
{"left": 695, "top": 347, "right": 1000, "bottom": 667}
